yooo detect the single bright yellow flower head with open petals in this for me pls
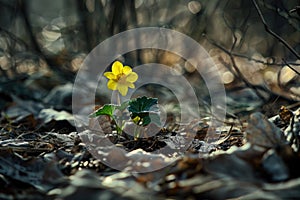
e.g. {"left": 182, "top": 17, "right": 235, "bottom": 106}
{"left": 104, "top": 61, "right": 138, "bottom": 96}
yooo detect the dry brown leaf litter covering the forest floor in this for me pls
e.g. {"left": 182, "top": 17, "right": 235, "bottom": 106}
{"left": 0, "top": 76, "right": 300, "bottom": 199}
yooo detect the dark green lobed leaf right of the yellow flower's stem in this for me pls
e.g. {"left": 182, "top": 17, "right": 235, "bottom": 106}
{"left": 128, "top": 96, "right": 160, "bottom": 126}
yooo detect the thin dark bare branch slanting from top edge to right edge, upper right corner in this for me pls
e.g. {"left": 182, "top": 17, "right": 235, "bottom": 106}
{"left": 252, "top": 0, "right": 300, "bottom": 59}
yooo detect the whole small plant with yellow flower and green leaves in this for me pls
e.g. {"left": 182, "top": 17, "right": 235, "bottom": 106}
{"left": 90, "top": 61, "right": 160, "bottom": 138}
